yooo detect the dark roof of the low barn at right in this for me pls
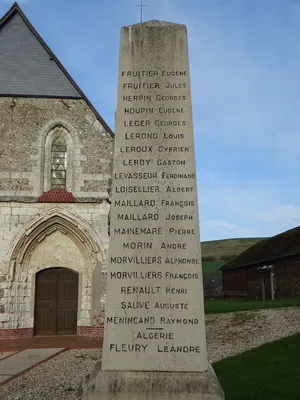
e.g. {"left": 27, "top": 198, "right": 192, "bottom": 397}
{"left": 220, "top": 226, "right": 300, "bottom": 270}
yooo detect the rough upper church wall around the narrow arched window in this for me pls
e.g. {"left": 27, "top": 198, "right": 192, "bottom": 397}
{"left": 0, "top": 97, "right": 113, "bottom": 202}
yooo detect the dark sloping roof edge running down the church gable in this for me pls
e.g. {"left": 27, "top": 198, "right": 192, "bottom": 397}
{"left": 0, "top": 2, "right": 114, "bottom": 136}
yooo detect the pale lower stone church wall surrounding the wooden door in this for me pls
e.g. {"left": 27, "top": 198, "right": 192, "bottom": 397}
{"left": 0, "top": 202, "right": 109, "bottom": 337}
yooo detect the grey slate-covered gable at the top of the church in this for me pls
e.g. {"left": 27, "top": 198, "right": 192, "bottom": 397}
{"left": 0, "top": 3, "right": 113, "bottom": 135}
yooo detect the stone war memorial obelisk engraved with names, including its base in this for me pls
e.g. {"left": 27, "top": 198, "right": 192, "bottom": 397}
{"left": 78, "top": 20, "right": 224, "bottom": 400}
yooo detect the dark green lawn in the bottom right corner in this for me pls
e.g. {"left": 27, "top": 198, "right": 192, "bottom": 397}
{"left": 213, "top": 334, "right": 300, "bottom": 400}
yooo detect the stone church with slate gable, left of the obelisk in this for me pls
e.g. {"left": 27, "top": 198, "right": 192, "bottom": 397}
{"left": 0, "top": 3, "right": 113, "bottom": 338}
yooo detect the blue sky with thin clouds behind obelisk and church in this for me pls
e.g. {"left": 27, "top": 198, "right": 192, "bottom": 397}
{"left": 0, "top": 0, "right": 300, "bottom": 241}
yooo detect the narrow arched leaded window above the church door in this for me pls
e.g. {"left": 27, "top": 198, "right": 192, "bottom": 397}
{"left": 51, "top": 136, "right": 67, "bottom": 189}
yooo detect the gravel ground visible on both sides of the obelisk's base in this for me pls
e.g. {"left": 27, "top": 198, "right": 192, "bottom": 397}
{"left": 0, "top": 307, "right": 300, "bottom": 400}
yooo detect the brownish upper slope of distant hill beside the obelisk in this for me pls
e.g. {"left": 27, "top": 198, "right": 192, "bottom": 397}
{"left": 201, "top": 238, "right": 264, "bottom": 262}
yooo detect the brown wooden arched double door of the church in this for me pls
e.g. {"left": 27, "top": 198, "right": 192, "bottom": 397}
{"left": 34, "top": 268, "right": 78, "bottom": 335}
